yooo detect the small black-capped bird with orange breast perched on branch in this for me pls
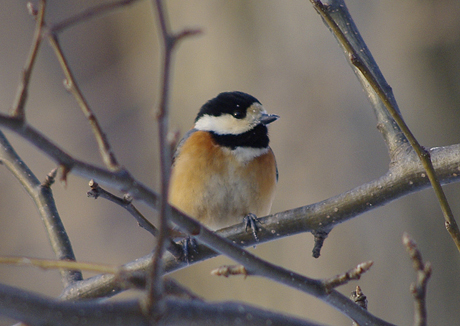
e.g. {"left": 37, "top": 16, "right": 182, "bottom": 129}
{"left": 168, "top": 91, "right": 279, "bottom": 240}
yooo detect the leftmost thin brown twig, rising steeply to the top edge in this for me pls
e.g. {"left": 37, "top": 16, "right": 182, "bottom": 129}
{"left": 11, "top": 0, "right": 46, "bottom": 119}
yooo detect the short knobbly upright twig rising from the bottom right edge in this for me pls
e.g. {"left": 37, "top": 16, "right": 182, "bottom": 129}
{"left": 403, "top": 232, "right": 431, "bottom": 326}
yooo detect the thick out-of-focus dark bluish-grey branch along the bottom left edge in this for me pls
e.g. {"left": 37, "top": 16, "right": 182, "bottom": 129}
{"left": 0, "top": 284, "right": 330, "bottom": 326}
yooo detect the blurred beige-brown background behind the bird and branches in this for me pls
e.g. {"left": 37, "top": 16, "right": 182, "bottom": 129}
{"left": 0, "top": 0, "right": 460, "bottom": 326}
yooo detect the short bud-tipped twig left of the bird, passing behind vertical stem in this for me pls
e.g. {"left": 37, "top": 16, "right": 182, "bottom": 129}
{"left": 87, "top": 180, "right": 184, "bottom": 259}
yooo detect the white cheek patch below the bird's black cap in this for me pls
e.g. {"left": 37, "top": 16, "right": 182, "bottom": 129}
{"left": 195, "top": 114, "right": 253, "bottom": 135}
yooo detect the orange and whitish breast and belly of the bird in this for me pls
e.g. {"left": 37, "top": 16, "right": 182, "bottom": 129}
{"left": 169, "top": 131, "right": 276, "bottom": 229}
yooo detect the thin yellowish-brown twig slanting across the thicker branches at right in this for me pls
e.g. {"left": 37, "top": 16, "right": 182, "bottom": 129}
{"left": 310, "top": 0, "right": 460, "bottom": 251}
